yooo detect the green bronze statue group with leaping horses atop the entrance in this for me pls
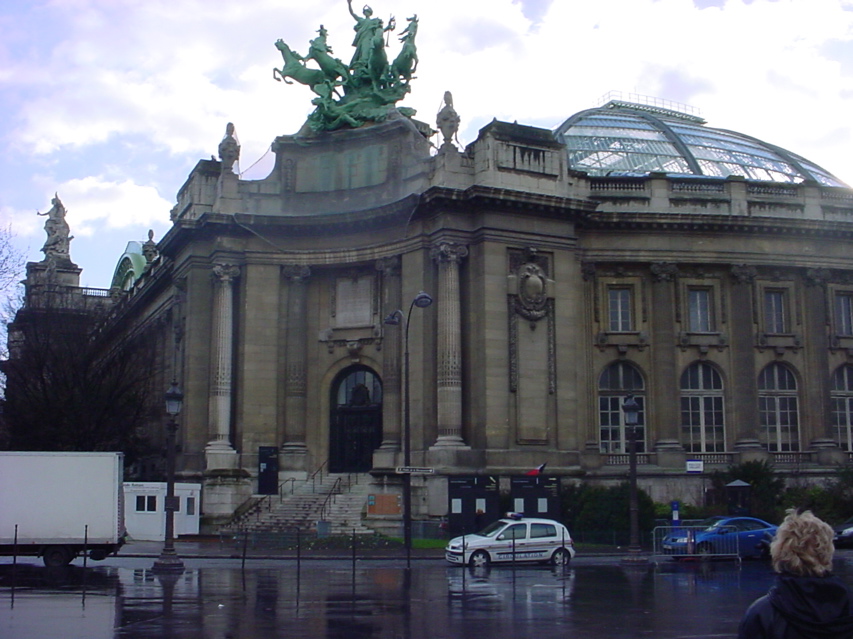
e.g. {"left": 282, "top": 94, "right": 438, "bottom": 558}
{"left": 273, "top": 0, "right": 418, "bottom": 131}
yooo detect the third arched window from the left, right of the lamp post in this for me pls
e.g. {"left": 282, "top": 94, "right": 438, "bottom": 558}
{"left": 758, "top": 362, "right": 800, "bottom": 453}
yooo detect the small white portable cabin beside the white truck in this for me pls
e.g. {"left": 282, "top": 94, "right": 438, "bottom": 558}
{"left": 124, "top": 481, "right": 201, "bottom": 541}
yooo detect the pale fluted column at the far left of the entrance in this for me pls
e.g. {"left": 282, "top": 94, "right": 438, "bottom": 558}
{"left": 205, "top": 263, "right": 240, "bottom": 470}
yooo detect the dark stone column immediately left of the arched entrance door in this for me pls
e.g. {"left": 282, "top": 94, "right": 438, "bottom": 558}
{"left": 281, "top": 265, "right": 311, "bottom": 470}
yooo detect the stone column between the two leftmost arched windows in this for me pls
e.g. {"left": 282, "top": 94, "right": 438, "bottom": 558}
{"left": 646, "top": 263, "right": 685, "bottom": 468}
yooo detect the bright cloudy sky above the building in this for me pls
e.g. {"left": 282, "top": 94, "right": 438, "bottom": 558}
{"left": 0, "top": 0, "right": 853, "bottom": 287}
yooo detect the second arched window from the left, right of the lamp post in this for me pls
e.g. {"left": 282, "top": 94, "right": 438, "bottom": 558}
{"left": 681, "top": 362, "right": 726, "bottom": 453}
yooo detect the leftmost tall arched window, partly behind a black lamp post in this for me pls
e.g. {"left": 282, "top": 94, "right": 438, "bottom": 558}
{"left": 598, "top": 362, "right": 646, "bottom": 453}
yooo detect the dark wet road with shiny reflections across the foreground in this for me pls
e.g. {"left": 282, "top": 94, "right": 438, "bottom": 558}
{"left": 5, "top": 559, "right": 853, "bottom": 639}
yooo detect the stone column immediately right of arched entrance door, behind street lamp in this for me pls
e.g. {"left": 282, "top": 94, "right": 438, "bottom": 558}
{"left": 373, "top": 256, "right": 405, "bottom": 456}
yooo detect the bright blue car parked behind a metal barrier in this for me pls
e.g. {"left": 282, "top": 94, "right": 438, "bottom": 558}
{"left": 661, "top": 517, "right": 777, "bottom": 558}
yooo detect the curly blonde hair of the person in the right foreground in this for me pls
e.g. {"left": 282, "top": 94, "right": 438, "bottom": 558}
{"left": 770, "top": 508, "right": 835, "bottom": 577}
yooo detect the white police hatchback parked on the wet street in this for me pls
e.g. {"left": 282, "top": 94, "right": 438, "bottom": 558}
{"left": 444, "top": 513, "right": 575, "bottom": 567}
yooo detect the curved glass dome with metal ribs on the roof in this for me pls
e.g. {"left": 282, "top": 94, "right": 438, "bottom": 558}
{"left": 554, "top": 96, "right": 847, "bottom": 187}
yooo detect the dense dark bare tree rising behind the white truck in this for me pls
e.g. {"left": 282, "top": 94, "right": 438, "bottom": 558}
{"left": 3, "top": 306, "right": 156, "bottom": 463}
